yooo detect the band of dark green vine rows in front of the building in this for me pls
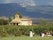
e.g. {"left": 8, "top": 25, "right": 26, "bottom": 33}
{"left": 0, "top": 24, "right": 53, "bottom": 37}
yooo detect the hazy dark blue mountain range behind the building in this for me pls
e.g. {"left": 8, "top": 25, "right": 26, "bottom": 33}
{"left": 0, "top": 3, "right": 53, "bottom": 19}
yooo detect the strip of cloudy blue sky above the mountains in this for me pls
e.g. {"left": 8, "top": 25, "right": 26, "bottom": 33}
{"left": 0, "top": 0, "right": 53, "bottom": 5}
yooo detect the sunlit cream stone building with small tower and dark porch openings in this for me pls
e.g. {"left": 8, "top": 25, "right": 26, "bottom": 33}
{"left": 9, "top": 14, "right": 32, "bottom": 25}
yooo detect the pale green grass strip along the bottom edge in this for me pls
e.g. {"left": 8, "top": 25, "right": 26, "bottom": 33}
{"left": 0, "top": 36, "right": 53, "bottom": 40}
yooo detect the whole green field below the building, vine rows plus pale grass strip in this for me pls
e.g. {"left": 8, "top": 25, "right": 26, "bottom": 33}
{"left": 0, "top": 25, "right": 53, "bottom": 40}
